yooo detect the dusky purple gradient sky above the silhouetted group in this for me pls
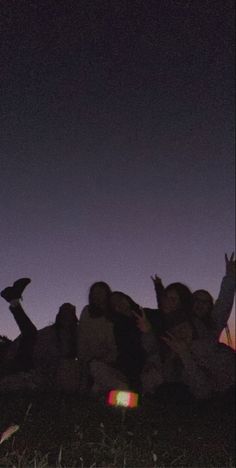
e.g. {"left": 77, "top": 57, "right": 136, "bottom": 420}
{"left": 0, "top": 0, "right": 235, "bottom": 344}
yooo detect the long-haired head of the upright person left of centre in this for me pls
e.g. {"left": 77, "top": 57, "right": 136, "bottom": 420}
{"left": 89, "top": 281, "right": 111, "bottom": 316}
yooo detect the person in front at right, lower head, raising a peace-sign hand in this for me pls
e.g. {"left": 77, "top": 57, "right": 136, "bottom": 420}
{"left": 135, "top": 310, "right": 235, "bottom": 399}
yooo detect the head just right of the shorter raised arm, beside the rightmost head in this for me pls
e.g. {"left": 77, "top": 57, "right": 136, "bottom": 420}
{"left": 161, "top": 283, "right": 193, "bottom": 314}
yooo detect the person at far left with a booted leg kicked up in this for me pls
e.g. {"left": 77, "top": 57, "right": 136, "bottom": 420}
{"left": 0, "top": 278, "right": 78, "bottom": 390}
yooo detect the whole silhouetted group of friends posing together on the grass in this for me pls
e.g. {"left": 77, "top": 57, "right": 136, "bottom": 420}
{"left": 0, "top": 254, "right": 235, "bottom": 399}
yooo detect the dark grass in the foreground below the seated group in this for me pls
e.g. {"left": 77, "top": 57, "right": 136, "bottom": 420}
{"left": 0, "top": 394, "right": 235, "bottom": 468}
